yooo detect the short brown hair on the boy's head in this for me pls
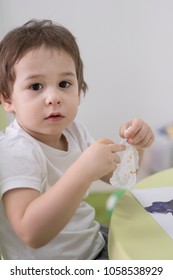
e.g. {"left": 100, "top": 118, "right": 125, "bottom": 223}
{"left": 0, "top": 20, "right": 87, "bottom": 103}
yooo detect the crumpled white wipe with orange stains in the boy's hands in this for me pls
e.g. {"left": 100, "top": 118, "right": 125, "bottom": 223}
{"left": 110, "top": 139, "right": 139, "bottom": 189}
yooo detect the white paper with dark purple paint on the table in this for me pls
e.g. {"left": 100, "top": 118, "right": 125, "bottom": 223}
{"left": 131, "top": 186, "right": 173, "bottom": 238}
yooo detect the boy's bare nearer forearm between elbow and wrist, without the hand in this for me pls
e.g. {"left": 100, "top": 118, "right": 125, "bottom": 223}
{"left": 19, "top": 166, "right": 91, "bottom": 247}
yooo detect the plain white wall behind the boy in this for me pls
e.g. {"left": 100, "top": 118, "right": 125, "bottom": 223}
{"left": 0, "top": 0, "right": 173, "bottom": 138}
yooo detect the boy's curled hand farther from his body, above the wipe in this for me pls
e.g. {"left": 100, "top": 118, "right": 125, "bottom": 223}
{"left": 120, "top": 119, "right": 154, "bottom": 149}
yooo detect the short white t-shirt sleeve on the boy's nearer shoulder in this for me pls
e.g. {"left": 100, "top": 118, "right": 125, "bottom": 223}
{"left": 0, "top": 134, "right": 45, "bottom": 198}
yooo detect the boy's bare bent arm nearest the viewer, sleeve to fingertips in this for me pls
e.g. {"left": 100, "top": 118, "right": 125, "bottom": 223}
{"left": 3, "top": 139, "right": 122, "bottom": 248}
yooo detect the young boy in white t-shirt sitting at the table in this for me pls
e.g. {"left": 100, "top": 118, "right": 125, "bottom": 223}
{"left": 0, "top": 20, "right": 154, "bottom": 259}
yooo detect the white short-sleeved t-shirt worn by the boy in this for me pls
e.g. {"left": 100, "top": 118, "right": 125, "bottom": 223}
{"left": 0, "top": 120, "right": 104, "bottom": 260}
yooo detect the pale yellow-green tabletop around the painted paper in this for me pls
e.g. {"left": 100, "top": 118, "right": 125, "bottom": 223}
{"left": 108, "top": 168, "right": 173, "bottom": 260}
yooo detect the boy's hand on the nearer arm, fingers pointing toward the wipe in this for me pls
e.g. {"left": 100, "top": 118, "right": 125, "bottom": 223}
{"left": 78, "top": 139, "right": 125, "bottom": 181}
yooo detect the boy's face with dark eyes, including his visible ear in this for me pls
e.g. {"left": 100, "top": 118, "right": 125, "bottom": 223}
{"left": 4, "top": 46, "right": 79, "bottom": 144}
